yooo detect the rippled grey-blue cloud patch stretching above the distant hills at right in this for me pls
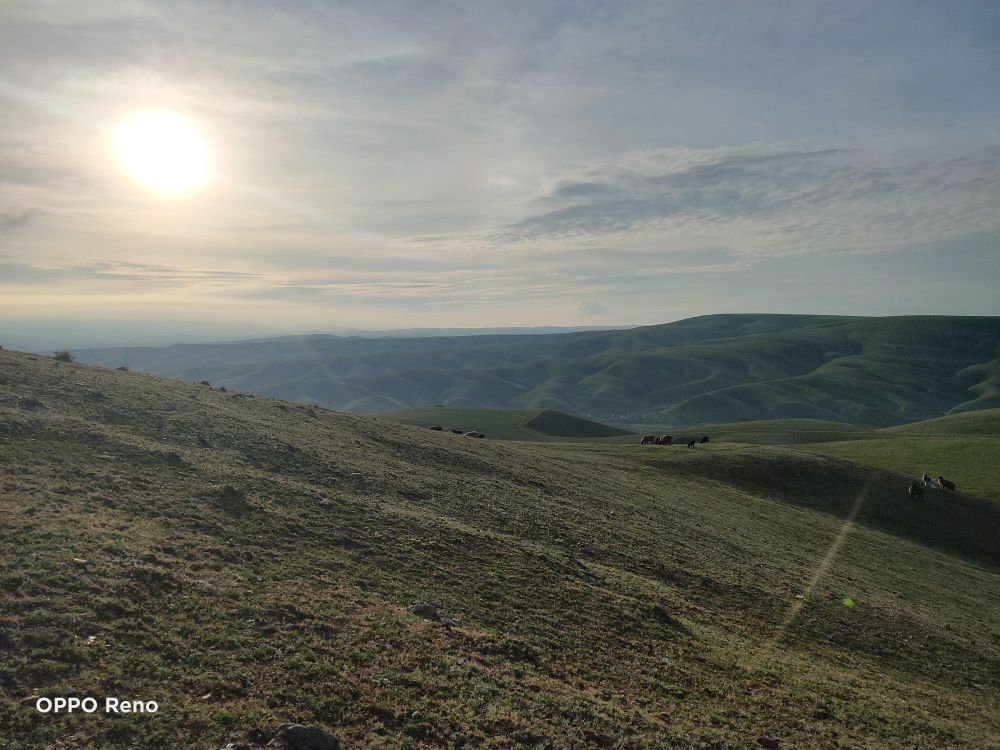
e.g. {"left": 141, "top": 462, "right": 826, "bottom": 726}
{"left": 491, "top": 146, "right": 1000, "bottom": 255}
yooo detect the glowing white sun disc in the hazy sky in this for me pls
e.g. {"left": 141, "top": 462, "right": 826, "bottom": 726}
{"left": 117, "top": 112, "right": 208, "bottom": 195}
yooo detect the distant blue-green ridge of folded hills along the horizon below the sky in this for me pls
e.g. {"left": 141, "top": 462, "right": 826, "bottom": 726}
{"left": 75, "top": 314, "right": 1000, "bottom": 426}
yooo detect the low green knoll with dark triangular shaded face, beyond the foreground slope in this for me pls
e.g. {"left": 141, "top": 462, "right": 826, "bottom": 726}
{"left": 378, "top": 406, "right": 632, "bottom": 440}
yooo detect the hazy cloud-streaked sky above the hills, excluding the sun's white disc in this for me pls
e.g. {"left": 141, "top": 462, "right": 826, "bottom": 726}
{"left": 0, "top": 0, "right": 1000, "bottom": 344}
